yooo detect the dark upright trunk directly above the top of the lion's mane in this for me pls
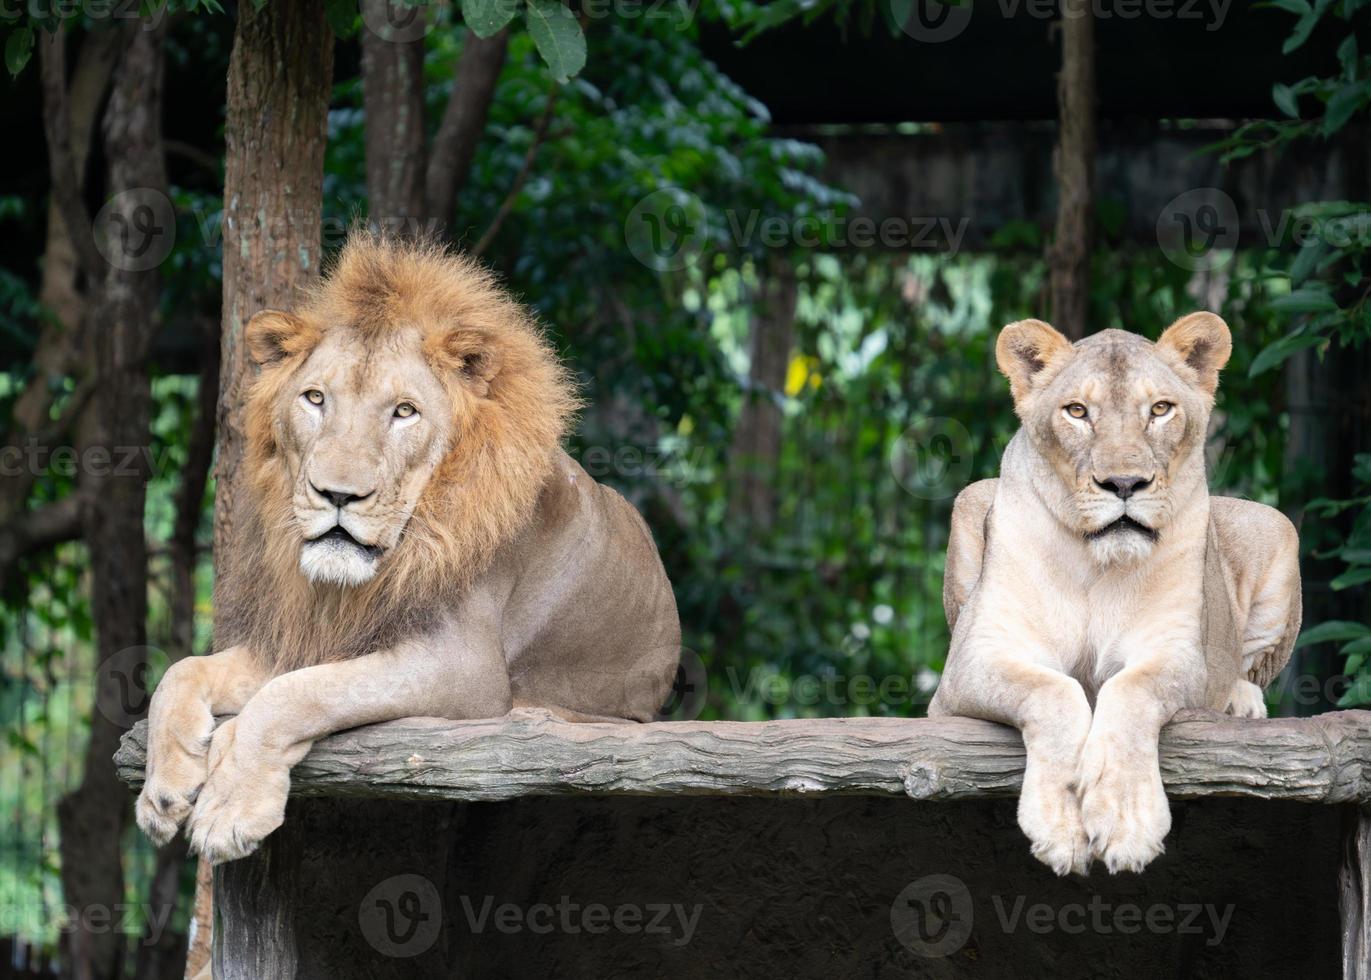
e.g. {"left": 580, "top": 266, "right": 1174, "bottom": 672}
{"left": 362, "top": 0, "right": 425, "bottom": 224}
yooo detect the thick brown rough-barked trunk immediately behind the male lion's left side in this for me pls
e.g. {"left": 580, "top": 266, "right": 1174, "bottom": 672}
{"left": 214, "top": 0, "right": 333, "bottom": 575}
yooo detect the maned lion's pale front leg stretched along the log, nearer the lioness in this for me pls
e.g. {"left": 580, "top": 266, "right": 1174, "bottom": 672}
{"left": 188, "top": 630, "right": 510, "bottom": 863}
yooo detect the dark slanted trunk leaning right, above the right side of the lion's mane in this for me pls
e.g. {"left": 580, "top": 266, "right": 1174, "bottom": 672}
{"left": 425, "top": 29, "right": 509, "bottom": 232}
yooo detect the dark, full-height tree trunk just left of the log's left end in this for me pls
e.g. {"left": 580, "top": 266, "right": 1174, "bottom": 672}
{"left": 58, "top": 21, "right": 166, "bottom": 980}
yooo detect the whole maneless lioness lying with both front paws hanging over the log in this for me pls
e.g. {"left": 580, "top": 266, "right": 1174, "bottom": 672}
{"left": 928, "top": 313, "right": 1300, "bottom": 874}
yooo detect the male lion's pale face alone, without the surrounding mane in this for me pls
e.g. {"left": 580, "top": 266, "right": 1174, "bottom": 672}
{"left": 274, "top": 329, "right": 454, "bottom": 585}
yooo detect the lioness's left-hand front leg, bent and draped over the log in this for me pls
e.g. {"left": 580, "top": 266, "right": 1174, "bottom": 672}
{"left": 928, "top": 650, "right": 1090, "bottom": 874}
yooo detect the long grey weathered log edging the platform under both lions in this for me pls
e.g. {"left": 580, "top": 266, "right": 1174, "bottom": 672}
{"left": 115, "top": 710, "right": 1371, "bottom": 803}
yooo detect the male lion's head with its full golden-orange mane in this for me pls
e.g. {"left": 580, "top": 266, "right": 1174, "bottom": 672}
{"left": 244, "top": 234, "right": 574, "bottom": 606}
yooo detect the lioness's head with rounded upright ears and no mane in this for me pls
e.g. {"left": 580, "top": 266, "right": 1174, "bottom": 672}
{"left": 997, "top": 313, "right": 1231, "bottom": 563}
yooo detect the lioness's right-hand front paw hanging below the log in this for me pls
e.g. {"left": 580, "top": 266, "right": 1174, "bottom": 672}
{"left": 1076, "top": 735, "right": 1171, "bottom": 874}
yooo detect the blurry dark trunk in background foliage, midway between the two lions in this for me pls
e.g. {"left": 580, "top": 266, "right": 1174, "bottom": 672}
{"left": 728, "top": 255, "right": 797, "bottom": 529}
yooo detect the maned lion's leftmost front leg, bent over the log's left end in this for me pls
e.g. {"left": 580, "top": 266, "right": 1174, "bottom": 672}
{"left": 134, "top": 647, "right": 266, "bottom": 844}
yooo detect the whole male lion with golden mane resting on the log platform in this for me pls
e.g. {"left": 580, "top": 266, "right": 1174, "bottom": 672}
{"left": 137, "top": 234, "right": 680, "bottom": 862}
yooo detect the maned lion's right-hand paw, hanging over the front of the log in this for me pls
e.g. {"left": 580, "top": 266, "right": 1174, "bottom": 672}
{"left": 186, "top": 718, "right": 291, "bottom": 865}
